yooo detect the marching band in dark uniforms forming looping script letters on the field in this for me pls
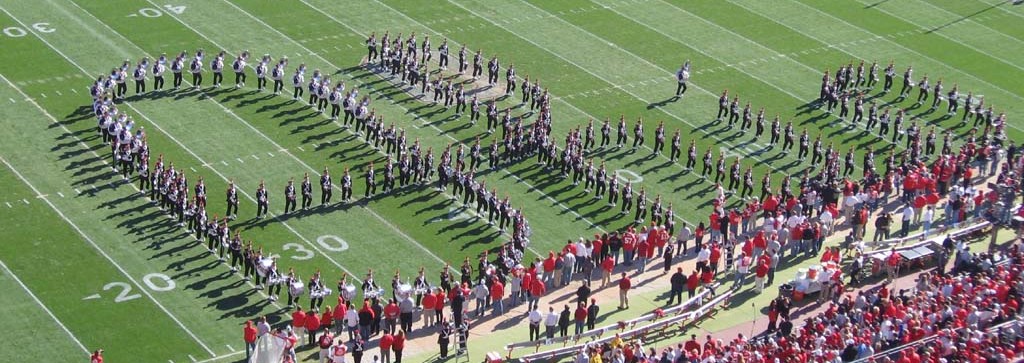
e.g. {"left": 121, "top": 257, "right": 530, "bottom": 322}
{"left": 81, "top": 26, "right": 1012, "bottom": 363}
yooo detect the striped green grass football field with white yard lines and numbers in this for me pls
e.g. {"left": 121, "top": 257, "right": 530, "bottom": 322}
{"left": 0, "top": 0, "right": 1024, "bottom": 362}
